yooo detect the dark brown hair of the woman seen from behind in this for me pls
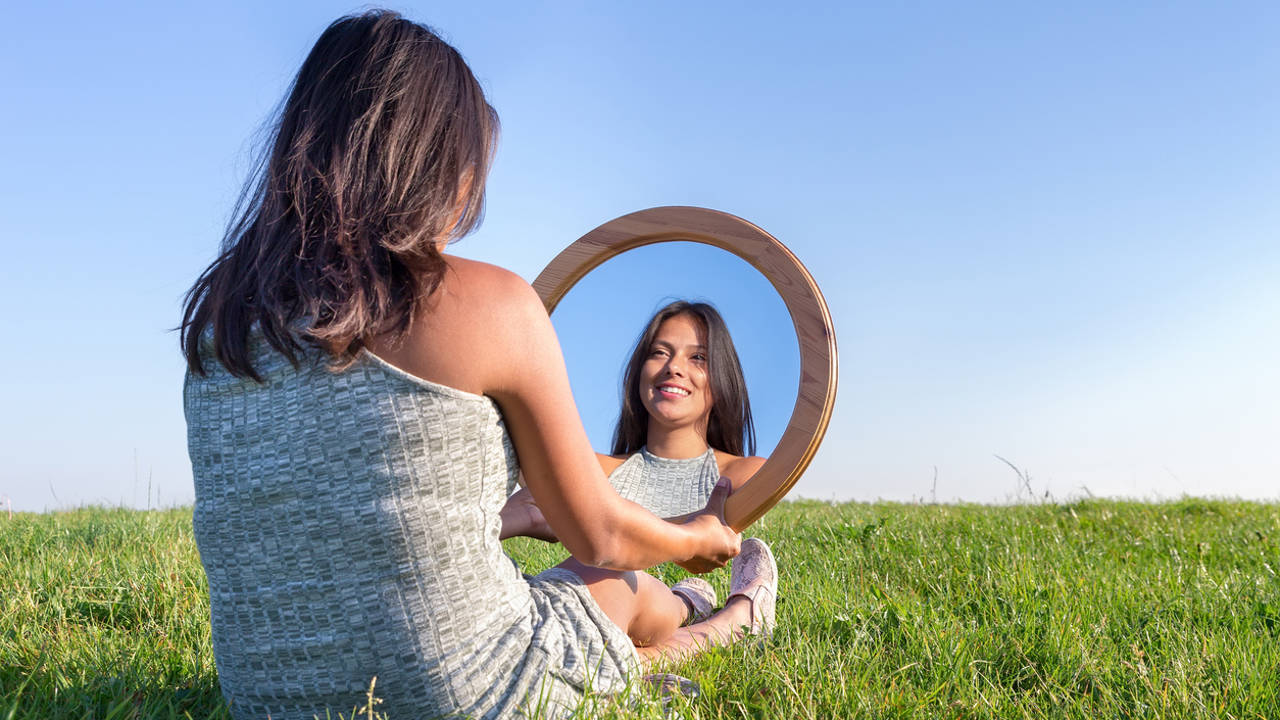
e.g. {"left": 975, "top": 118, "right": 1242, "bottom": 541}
{"left": 179, "top": 10, "right": 498, "bottom": 380}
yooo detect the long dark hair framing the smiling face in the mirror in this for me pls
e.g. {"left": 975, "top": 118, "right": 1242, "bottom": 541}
{"left": 613, "top": 300, "right": 755, "bottom": 456}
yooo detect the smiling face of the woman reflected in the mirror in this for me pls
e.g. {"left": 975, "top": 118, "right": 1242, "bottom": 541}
{"left": 640, "top": 314, "right": 712, "bottom": 434}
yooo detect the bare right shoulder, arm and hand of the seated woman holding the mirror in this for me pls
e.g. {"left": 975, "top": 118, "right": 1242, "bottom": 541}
{"left": 374, "top": 258, "right": 739, "bottom": 570}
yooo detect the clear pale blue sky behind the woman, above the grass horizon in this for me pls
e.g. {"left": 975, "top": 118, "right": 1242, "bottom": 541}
{"left": 0, "top": 1, "right": 1280, "bottom": 510}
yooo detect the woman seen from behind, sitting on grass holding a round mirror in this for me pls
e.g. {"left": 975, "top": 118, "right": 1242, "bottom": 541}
{"left": 182, "top": 12, "right": 768, "bottom": 719}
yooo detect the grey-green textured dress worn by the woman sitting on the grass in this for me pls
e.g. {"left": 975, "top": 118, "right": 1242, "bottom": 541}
{"left": 183, "top": 340, "right": 636, "bottom": 720}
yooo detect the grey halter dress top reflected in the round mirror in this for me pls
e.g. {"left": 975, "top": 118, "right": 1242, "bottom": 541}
{"left": 609, "top": 447, "right": 719, "bottom": 518}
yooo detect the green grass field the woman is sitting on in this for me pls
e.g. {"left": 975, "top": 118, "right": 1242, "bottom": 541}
{"left": 0, "top": 500, "right": 1280, "bottom": 720}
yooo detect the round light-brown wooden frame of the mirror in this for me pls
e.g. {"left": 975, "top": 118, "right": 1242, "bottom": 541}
{"left": 534, "top": 206, "right": 836, "bottom": 532}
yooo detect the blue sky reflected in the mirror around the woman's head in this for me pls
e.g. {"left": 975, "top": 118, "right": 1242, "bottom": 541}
{"left": 552, "top": 242, "right": 800, "bottom": 456}
